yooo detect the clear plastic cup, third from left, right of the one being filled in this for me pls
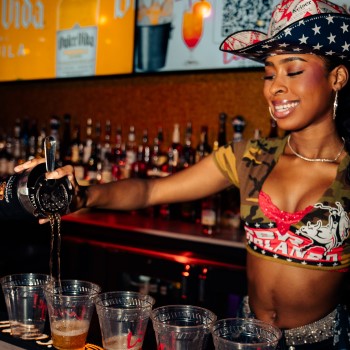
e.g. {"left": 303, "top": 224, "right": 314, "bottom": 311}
{"left": 95, "top": 291, "right": 155, "bottom": 350}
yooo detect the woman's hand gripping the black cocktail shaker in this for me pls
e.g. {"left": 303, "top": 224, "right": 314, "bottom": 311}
{"left": 14, "top": 158, "right": 88, "bottom": 224}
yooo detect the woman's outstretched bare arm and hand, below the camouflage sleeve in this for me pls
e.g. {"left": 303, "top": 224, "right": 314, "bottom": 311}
{"left": 15, "top": 155, "right": 230, "bottom": 211}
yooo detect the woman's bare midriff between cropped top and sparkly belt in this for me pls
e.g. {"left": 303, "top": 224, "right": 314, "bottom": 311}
{"left": 247, "top": 254, "right": 346, "bottom": 329}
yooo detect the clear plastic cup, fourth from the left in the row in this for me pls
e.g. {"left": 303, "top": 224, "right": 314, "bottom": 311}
{"left": 151, "top": 305, "right": 217, "bottom": 350}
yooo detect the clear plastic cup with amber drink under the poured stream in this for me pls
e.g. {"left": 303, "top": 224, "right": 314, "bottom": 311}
{"left": 44, "top": 280, "right": 101, "bottom": 350}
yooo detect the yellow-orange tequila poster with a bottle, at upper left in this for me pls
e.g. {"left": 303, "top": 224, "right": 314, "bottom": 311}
{"left": 0, "top": 0, "right": 135, "bottom": 81}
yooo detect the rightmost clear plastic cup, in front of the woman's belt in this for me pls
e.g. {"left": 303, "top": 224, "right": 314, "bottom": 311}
{"left": 210, "top": 318, "right": 282, "bottom": 350}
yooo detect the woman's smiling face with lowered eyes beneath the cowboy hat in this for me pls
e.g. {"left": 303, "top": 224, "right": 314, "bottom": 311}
{"left": 264, "top": 54, "right": 334, "bottom": 130}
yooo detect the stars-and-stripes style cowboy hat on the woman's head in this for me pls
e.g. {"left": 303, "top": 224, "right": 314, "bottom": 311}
{"left": 220, "top": 0, "right": 350, "bottom": 63}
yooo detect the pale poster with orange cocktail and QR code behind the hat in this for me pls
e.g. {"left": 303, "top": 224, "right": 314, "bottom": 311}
{"left": 134, "top": 0, "right": 350, "bottom": 73}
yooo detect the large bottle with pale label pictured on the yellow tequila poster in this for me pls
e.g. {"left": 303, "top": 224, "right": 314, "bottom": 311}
{"left": 56, "top": 0, "right": 99, "bottom": 77}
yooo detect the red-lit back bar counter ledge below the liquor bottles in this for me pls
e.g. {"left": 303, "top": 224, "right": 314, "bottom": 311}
{"left": 62, "top": 209, "right": 245, "bottom": 271}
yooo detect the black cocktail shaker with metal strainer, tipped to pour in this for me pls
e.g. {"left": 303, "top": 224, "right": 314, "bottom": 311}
{"left": 0, "top": 136, "right": 73, "bottom": 220}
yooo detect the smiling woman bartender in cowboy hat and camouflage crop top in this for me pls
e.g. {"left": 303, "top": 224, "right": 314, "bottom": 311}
{"left": 16, "top": 0, "right": 350, "bottom": 349}
